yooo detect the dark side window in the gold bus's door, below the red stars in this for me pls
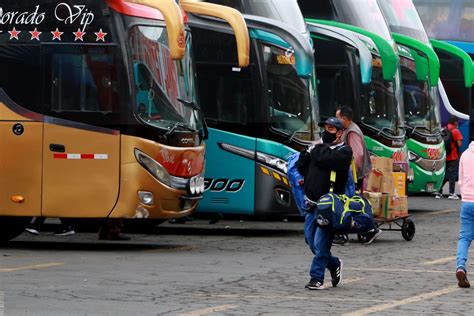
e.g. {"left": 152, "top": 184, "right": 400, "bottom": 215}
{"left": 44, "top": 46, "right": 120, "bottom": 116}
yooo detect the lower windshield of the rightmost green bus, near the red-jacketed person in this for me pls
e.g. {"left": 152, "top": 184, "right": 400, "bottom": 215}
{"left": 401, "top": 58, "right": 440, "bottom": 134}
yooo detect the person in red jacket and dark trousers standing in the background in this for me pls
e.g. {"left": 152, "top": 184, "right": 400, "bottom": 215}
{"left": 435, "top": 116, "right": 462, "bottom": 200}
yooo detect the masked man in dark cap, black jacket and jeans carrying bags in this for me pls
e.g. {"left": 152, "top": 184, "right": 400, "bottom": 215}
{"left": 298, "top": 117, "right": 352, "bottom": 290}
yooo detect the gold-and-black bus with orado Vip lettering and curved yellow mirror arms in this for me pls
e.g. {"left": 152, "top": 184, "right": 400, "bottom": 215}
{"left": 0, "top": 0, "right": 249, "bottom": 241}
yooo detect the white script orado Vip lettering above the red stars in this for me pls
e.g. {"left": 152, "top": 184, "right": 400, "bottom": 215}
{"left": 0, "top": 2, "right": 95, "bottom": 31}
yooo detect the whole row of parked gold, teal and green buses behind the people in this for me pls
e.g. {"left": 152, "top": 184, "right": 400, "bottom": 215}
{"left": 0, "top": 0, "right": 474, "bottom": 240}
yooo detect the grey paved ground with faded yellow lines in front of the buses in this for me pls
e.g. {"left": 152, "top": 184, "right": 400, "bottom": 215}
{"left": 0, "top": 196, "right": 474, "bottom": 316}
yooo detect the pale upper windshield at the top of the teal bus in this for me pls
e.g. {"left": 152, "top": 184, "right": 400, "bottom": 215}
{"left": 206, "top": 0, "right": 306, "bottom": 33}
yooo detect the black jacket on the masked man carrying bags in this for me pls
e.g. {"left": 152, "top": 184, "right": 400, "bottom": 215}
{"left": 297, "top": 143, "right": 352, "bottom": 202}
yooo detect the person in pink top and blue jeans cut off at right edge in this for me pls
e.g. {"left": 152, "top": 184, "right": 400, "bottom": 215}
{"left": 456, "top": 142, "right": 474, "bottom": 287}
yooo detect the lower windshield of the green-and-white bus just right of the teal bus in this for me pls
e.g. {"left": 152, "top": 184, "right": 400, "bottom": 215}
{"left": 361, "top": 57, "right": 403, "bottom": 136}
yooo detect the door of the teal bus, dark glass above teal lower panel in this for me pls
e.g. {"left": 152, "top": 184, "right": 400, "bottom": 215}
{"left": 189, "top": 20, "right": 259, "bottom": 215}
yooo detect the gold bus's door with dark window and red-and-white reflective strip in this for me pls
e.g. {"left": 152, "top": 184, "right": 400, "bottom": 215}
{"left": 42, "top": 45, "right": 120, "bottom": 217}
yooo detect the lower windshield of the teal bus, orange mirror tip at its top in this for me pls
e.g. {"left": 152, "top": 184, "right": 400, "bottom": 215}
{"left": 262, "top": 44, "right": 314, "bottom": 140}
